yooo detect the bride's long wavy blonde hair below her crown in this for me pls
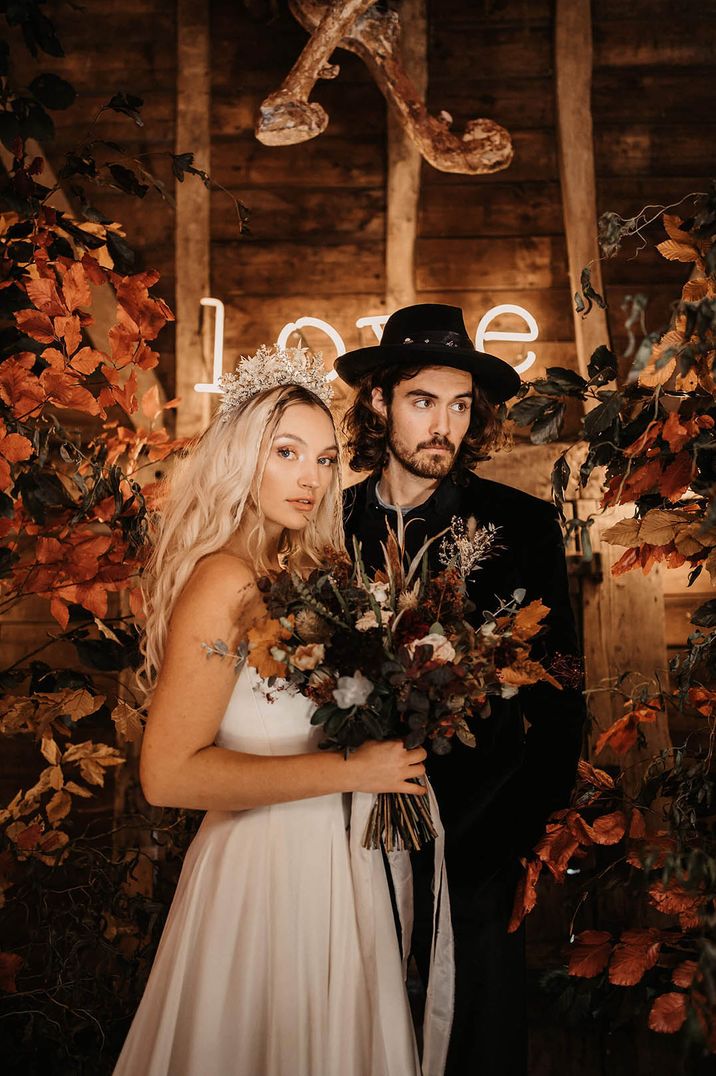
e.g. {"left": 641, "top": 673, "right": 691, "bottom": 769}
{"left": 137, "top": 385, "right": 345, "bottom": 702}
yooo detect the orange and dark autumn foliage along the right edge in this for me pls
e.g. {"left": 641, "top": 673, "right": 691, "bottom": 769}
{"left": 510, "top": 191, "right": 716, "bottom": 1052}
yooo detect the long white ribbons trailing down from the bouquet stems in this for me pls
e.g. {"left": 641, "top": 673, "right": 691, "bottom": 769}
{"left": 350, "top": 781, "right": 454, "bottom": 1076}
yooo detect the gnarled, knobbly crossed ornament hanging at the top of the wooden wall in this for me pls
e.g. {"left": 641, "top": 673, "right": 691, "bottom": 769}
{"left": 256, "top": 0, "right": 513, "bottom": 175}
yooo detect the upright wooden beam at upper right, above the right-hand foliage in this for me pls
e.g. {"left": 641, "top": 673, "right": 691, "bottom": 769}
{"left": 554, "top": 0, "right": 609, "bottom": 378}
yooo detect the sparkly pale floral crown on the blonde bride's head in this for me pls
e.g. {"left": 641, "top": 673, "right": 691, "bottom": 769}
{"left": 219, "top": 343, "right": 333, "bottom": 419}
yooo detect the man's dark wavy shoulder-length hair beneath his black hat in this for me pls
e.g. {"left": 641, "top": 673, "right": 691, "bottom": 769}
{"left": 342, "top": 364, "right": 511, "bottom": 481}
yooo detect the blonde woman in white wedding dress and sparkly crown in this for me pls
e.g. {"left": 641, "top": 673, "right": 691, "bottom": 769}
{"left": 114, "top": 348, "right": 426, "bottom": 1076}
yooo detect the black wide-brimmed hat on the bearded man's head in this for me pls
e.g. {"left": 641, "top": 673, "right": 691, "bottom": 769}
{"left": 336, "top": 302, "right": 520, "bottom": 404}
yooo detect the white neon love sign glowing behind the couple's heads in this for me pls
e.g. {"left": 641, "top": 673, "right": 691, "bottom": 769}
{"left": 194, "top": 296, "right": 539, "bottom": 393}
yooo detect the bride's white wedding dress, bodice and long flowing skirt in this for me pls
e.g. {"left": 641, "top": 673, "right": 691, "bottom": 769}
{"left": 114, "top": 666, "right": 451, "bottom": 1076}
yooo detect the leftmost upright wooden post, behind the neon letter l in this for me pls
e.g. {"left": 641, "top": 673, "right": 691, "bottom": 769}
{"left": 174, "top": 0, "right": 212, "bottom": 437}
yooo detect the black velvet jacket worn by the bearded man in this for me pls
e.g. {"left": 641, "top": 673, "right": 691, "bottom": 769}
{"left": 345, "top": 475, "right": 586, "bottom": 884}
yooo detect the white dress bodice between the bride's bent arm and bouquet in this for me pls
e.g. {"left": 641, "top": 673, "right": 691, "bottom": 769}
{"left": 214, "top": 665, "right": 323, "bottom": 754}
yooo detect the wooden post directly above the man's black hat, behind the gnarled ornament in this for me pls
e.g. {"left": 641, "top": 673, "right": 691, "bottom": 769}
{"left": 385, "top": 0, "right": 427, "bottom": 313}
